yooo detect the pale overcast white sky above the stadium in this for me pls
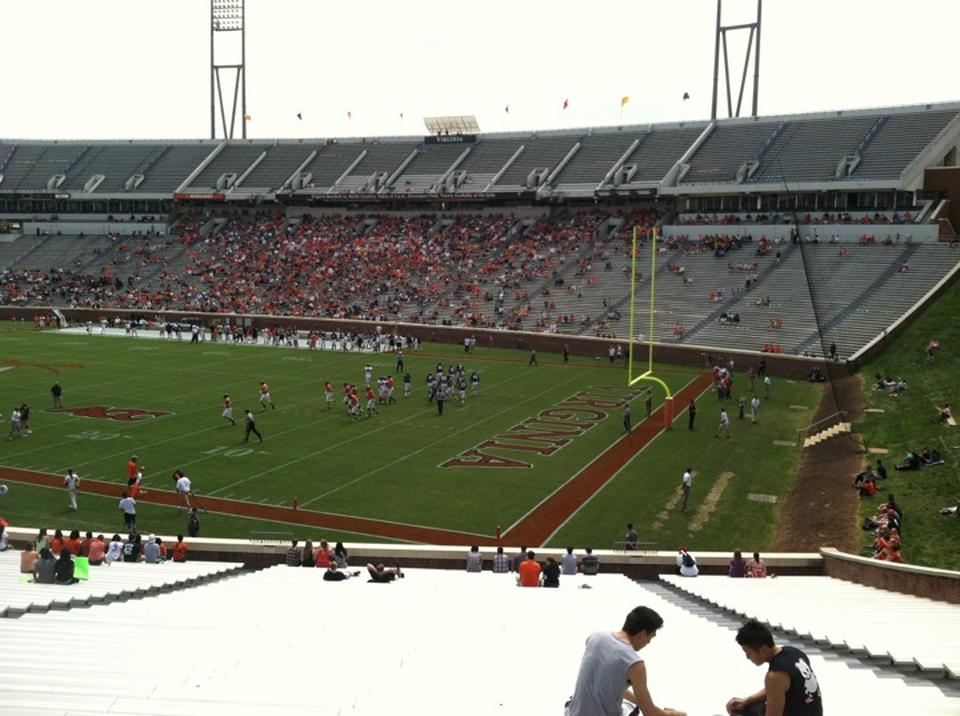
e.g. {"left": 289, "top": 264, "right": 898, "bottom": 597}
{"left": 0, "top": 0, "right": 960, "bottom": 139}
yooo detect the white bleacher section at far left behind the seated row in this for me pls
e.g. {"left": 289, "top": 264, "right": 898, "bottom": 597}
{"left": 0, "top": 550, "right": 240, "bottom": 620}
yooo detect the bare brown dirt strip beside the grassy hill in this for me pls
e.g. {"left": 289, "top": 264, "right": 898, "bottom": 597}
{"left": 771, "top": 375, "right": 866, "bottom": 553}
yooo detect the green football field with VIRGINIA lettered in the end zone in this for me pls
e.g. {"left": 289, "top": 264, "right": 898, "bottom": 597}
{"left": 0, "top": 330, "right": 819, "bottom": 550}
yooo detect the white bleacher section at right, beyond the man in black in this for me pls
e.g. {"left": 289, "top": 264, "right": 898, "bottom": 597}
{"left": 661, "top": 575, "right": 960, "bottom": 680}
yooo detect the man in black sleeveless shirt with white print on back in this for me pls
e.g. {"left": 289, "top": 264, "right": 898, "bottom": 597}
{"left": 727, "top": 620, "right": 823, "bottom": 716}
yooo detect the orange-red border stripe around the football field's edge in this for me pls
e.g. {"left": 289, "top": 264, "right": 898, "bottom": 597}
{"left": 0, "top": 373, "right": 712, "bottom": 547}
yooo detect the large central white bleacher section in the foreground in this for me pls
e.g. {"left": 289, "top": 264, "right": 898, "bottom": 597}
{"left": 0, "top": 566, "right": 957, "bottom": 716}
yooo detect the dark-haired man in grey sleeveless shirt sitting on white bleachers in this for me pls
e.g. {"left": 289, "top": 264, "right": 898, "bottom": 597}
{"left": 564, "top": 607, "right": 686, "bottom": 716}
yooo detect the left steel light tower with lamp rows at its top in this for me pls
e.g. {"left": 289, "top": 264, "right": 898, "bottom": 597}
{"left": 210, "top": 0, "right": 249, "bottom": 139}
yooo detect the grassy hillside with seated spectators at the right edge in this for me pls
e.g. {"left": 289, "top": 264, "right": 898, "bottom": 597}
{"left": 855, "top": 287, "right": 960, "bottom": 569}
